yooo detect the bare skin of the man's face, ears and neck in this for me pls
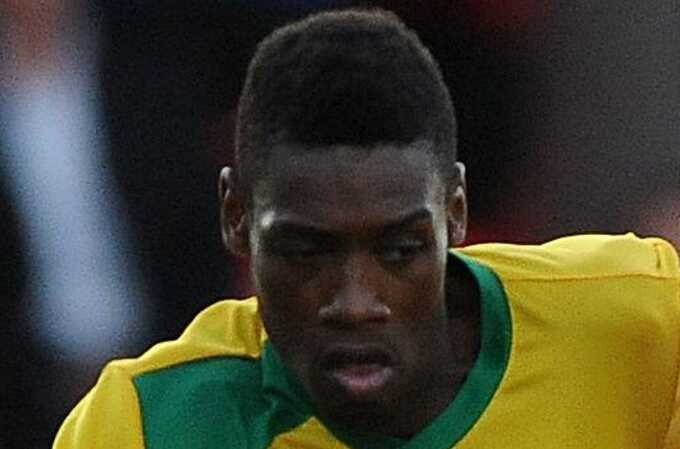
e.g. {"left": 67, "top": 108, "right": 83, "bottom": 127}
{"left": 220, "top": 143, "right": 479, "bottom": 438}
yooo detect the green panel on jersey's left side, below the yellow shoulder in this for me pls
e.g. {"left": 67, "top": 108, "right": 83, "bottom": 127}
{"left": 134, "top": 357, "right": 309, "bottom": 449}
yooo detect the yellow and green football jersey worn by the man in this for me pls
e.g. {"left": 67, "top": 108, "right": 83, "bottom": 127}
{"left": 54, "top": 234, "right": 680, "bottom": 449}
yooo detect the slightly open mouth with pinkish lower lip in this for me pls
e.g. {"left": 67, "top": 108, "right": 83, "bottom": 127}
{"left": 321, "top": 346, "right": 395, "bottom": 400}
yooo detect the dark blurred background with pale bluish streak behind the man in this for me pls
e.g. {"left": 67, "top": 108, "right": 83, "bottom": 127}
{"left": 0, "top": 0, "right": 680, "bottom": 448}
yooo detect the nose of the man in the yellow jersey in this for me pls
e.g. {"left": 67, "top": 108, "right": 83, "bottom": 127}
{"left": 319, "top": 248, "right": 392, "bottom": 327}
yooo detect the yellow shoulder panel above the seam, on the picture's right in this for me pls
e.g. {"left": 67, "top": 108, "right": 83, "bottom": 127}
{"left": 459, "top": 234, "right": 680, "bottom": 281}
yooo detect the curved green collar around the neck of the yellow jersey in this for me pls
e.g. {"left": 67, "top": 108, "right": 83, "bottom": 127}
{"left": 262, "top": 251, "right": 512, "bottom": 449}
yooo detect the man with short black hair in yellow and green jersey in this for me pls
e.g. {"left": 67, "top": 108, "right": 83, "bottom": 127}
{"left": 55, "top": 7, "right": 680, "bottom": 449}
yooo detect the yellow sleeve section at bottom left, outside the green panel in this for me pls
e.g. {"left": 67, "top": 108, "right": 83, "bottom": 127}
{"left": 52, "top": 362, "right": 144, "bottom": 449}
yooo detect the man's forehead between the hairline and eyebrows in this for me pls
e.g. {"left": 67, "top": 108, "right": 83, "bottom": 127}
{"left": 252, "top": 144, "right": 444, "bottom": 228}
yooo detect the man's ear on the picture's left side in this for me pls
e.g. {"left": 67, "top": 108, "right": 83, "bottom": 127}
{"left": 218, "top": 167, "right": 250, "bottom": 256}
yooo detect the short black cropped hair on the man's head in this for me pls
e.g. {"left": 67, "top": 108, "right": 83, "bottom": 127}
{"left": 235, "top": 9, "right": 456, "bottom": 189}
